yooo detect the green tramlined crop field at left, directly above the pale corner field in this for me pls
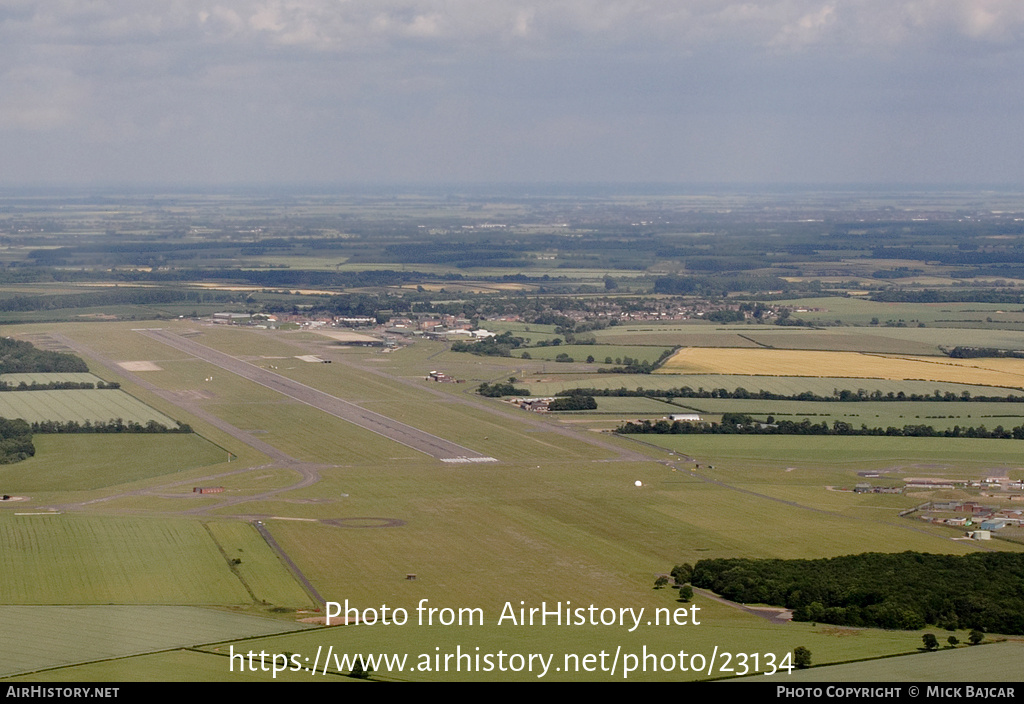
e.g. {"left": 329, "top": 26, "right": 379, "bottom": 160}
{"left": 0, "top": 513, "right": 252, "bottom": 606}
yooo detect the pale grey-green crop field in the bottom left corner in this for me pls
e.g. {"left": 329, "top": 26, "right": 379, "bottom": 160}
{"left": 0, "top": 605, "right": 305, "bottom": 681}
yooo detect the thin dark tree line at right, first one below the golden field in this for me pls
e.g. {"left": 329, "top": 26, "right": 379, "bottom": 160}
{"left": 555, "top": 386, "right": 1024, "bottom": 403}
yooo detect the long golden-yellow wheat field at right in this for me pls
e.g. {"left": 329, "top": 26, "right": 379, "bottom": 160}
{"left": 658, "top": 347, "right": 1024, "bottom": 388}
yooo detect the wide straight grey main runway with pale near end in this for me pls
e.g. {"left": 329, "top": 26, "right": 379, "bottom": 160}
{"left": 136, "top": 328, "right": 497, "bottom": 463}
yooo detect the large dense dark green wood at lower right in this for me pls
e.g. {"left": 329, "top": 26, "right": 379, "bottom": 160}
{"left": 691, "top": 552, "right": 1024, "bottom": 634}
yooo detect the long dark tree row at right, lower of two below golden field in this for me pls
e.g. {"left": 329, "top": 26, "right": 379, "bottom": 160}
{"left": 615, "top": 413, "right": 1024, "bottom": 440}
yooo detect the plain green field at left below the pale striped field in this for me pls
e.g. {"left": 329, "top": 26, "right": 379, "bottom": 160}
{"left": 0, "top": 431, "right": 225, "bottom": 493}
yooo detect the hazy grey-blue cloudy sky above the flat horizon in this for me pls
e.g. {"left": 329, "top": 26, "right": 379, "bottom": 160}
{"left": 0, "top": 0, "right": 1024, "bottom": 186}
